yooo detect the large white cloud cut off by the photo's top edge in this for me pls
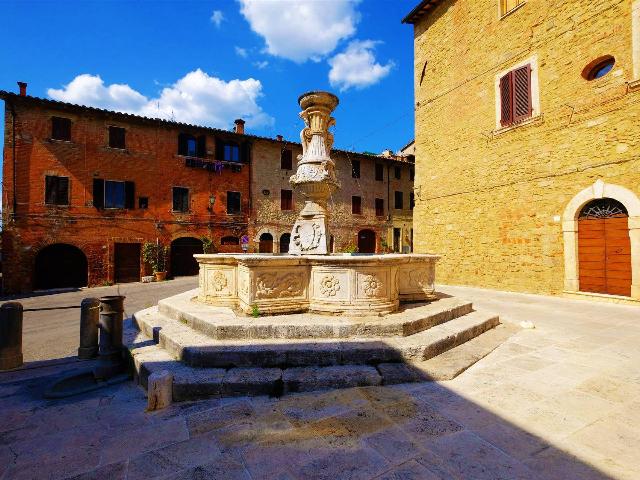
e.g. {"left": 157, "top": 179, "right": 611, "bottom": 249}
{"left": 238, "top": 0, "right": 359, "bottom": 63}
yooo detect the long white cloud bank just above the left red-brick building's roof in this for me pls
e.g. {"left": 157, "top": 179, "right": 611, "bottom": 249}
{"left": 47, "top": 69, "right": 274, "bottom": 129}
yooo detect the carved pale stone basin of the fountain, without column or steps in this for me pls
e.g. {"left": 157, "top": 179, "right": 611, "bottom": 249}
{"left": 194, "top": 254, "right": 440, "bottom": 316}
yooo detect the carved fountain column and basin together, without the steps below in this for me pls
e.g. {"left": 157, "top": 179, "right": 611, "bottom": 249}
{"left": 195, "top": 91, "right": 439, "bottom": 315}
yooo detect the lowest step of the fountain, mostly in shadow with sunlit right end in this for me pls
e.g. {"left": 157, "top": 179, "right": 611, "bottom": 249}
{"left": 130, "top": 325, "right": 517, "bottom": 402}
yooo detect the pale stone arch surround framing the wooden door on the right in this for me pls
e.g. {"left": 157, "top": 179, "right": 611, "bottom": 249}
{"left": 562, "top": 180, "right": 640, "bottom": 300}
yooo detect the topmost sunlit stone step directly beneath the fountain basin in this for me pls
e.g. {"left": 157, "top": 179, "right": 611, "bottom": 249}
{"left": 149, "top": 291, "right": 473, "bottom": 340}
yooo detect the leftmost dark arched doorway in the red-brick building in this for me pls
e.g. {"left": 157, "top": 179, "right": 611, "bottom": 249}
{"left": 34, "top": 243, "right": 89, "bottom": 289}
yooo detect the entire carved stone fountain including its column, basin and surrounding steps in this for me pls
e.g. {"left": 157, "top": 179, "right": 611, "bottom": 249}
{"left": 128, "top": 92, "right": 500, "bottom": 400}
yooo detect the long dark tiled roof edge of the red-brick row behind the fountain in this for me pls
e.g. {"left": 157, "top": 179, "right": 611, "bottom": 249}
{"left": 0, "top": 90, "right": 410, "bottom": 162}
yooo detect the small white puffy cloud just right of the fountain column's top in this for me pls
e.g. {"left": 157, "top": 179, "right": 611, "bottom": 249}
{"left": 329, "top": 40, "right": 394, "bottom": 91}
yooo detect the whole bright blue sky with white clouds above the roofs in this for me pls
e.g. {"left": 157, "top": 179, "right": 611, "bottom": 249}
{"left": 0, "top": 0, "right": 418, "bottom": 156}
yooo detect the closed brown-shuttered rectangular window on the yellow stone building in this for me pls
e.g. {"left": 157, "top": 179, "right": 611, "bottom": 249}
{"left": 500, "top": 64, "right": 533, "bottom": 127}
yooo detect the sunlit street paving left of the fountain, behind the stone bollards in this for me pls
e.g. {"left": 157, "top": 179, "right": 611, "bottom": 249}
{"left": 0, "top": 276, "right": 198, "bottom": 361}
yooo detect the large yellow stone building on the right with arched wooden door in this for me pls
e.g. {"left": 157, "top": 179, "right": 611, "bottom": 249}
{"left": 404, "top": 0, "right": 640, "bottom": 301}
